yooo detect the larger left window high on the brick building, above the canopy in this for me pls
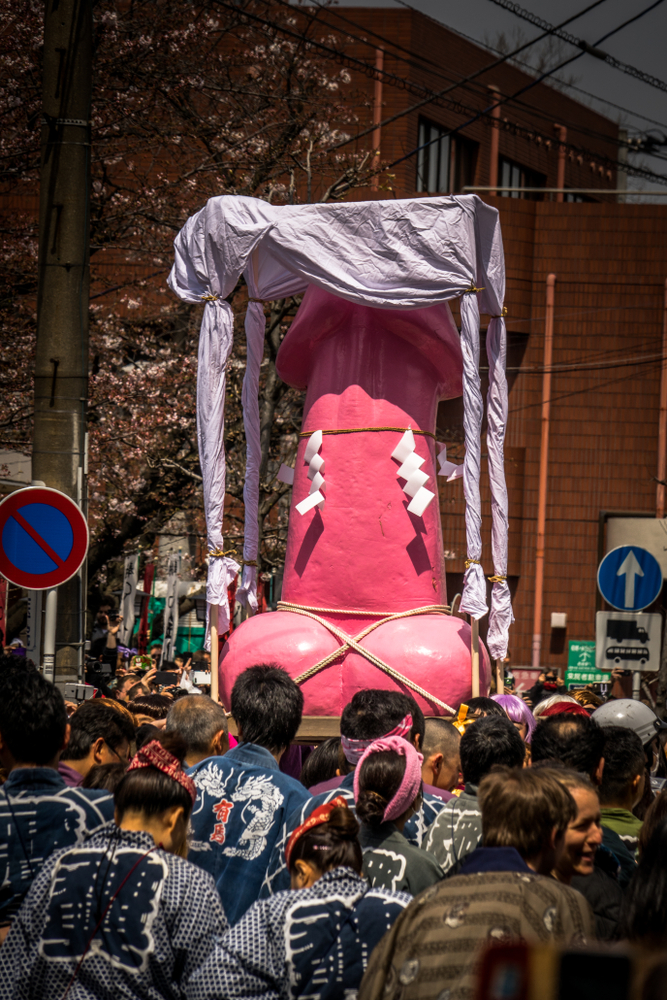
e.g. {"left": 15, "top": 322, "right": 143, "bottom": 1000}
{"left": 417, "top": 118, "right": 477, "bottom": 194}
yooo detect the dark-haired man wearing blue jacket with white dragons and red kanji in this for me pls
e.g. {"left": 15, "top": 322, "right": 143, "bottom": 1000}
{"left": 188, "top": 666, "right": 310, "bottom": 924}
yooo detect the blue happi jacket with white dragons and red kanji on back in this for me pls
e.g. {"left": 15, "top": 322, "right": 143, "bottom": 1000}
{"left": 188, "top": 743, "right": 311, "bottom": 924}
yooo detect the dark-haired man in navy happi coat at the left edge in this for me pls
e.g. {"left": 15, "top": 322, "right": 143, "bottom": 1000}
{"left": 0, "top": 657, "right": 113, "bottom": 941}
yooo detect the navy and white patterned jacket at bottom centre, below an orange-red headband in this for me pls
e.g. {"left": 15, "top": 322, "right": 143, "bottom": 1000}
{"left": 218, "top": 868, "right": 412, "bottom": 1000}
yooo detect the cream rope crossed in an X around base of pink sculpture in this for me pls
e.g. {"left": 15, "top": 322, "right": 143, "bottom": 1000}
{"left": 277, "top": 601, "right": 454, "bottom": 715}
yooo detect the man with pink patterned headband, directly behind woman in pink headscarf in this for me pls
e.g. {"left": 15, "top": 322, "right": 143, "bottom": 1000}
{"left": 261, "top": 688, "right": 446, "bottom": 898}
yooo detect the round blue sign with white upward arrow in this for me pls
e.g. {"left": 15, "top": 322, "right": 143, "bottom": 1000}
{"left": 598, "top": 545, "right": 662, "bottom": 611}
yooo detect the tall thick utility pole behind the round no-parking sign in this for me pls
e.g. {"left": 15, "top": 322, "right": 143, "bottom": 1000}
{"left": 32, "top": 0, "right": 93, "bottom": 680}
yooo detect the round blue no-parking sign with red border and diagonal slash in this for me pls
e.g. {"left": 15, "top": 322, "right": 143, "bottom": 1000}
{"left": 0, "top": 486, "right": 88, "bottom": 590}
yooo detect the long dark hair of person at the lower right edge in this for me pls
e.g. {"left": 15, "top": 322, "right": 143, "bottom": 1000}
{"left": 620, "top": 819, "right": 667, "bottom": 949}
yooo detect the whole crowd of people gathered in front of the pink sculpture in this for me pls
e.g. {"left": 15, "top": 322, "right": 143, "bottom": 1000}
{"left": 0, "top": 652, "right": 667, "bottom": 1000}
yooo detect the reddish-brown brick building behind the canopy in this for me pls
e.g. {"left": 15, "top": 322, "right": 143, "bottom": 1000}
{"left": 328, "top": 8, "right": 667, "bottom": 668}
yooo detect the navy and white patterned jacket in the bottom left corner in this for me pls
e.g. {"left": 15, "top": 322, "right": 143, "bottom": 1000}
{"left": 0, "top": 823, "right": 227, "bottom": 1000}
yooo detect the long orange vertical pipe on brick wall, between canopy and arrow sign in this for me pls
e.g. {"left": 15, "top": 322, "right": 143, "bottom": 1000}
{"left": 533, "top": 274, "right": 556, "bottom": 670}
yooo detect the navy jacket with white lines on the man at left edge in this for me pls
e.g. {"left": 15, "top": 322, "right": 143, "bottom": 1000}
{"left": 0, "top": 767, "right": 113, "bottom": 924}
